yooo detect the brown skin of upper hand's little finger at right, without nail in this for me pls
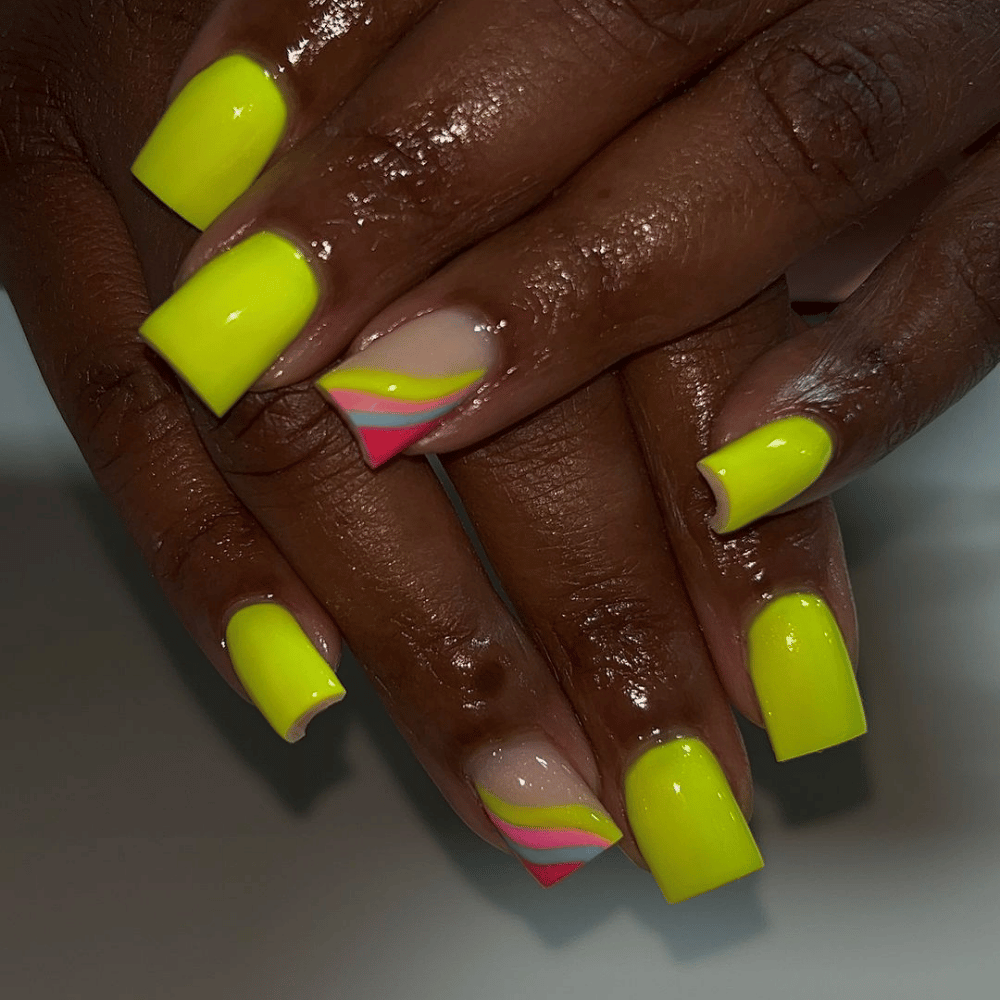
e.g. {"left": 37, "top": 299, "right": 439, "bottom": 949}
{"left": 711, "top": 141, "right": 1000, "bottom": 524}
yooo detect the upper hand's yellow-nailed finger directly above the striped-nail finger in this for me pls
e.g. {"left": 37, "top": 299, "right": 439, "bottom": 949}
{"left": 135, "top": 0, "right": 794, "bottom": 413}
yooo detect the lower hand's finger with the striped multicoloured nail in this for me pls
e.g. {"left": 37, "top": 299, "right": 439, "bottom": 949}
{"left": 194, "top": 388, "right": 621, "bottom": 885}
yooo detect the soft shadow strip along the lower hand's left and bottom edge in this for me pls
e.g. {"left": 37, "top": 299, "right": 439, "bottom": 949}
{"left": 47, "top": 470, "right": 766, "bottom": 962}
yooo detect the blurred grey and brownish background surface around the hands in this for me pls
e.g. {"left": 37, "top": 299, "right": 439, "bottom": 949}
{"left": 0, "top": 286, "right": 1000, "bottom": 1000}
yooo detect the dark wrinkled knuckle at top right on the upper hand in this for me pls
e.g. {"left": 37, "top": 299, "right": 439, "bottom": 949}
{"left": 751, "top": 19, "right": 913, "bottom": 215}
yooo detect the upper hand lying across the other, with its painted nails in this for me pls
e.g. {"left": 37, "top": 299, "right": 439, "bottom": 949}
{"left": 125, "top": 0, "right": 1000, "bottom": 496}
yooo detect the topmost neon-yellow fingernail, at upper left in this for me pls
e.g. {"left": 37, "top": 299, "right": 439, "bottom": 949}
{"left": 132, "top": 55, "right": 288, "bottom": 229}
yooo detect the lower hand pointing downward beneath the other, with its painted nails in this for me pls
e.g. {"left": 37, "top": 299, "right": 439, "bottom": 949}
{"left": 0, "top": 5, "right": 864, "bottom": 899}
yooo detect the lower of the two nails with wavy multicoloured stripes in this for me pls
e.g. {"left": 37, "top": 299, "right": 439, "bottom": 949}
{"left": 467, "top": 736, "right": 622, "bottom": 888}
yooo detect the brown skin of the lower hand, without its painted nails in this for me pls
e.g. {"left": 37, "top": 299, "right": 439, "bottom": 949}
{"left": 0, "top": 0, "right": 853, "bottom": 876}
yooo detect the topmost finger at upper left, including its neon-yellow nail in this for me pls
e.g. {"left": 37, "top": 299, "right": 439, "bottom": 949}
{"left": 132, "top": 0, "right": 436, "bottom": 229}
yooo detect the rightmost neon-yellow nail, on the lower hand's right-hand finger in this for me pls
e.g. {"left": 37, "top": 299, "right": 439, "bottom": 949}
{"left": 747, "top": 594, "right": 868, "bottom": 760}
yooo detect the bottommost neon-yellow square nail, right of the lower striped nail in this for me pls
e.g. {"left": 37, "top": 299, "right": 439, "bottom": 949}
{"left": 625, "top": 738, "right": 764, "bottom": 903}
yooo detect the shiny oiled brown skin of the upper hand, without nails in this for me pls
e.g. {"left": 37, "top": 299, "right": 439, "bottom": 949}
{"left": 143, "top": 0, "right": 1000, "bottom": 508}
